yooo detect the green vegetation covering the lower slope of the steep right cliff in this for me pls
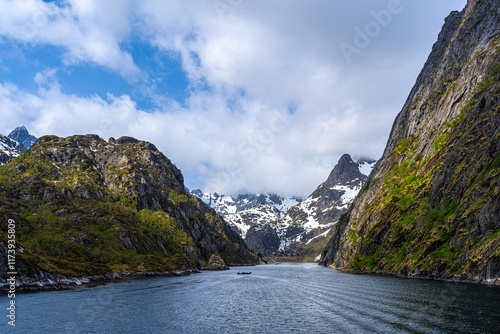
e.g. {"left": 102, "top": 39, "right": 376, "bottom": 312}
{"left": 347, "top": 59, "right": 500, "bottom": 276}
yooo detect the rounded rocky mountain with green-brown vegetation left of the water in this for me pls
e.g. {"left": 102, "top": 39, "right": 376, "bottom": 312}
{"left": 0, "top": 135, "right": 259, "bottom": 287}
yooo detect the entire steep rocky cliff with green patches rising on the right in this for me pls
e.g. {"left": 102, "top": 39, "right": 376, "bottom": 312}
{"left": 320, "top": 0, "right": 500, "bottom": 283}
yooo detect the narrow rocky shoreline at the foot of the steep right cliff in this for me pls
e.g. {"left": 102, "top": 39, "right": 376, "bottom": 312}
{"left": 330, "top": 265, "right": 500, "bottom": 287}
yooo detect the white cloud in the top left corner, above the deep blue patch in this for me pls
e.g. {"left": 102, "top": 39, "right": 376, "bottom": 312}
{"left": 0, "top": 0, "right": 141, "bottom": 80}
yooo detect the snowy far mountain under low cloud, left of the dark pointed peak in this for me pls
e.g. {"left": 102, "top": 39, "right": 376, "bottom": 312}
{"left": 191, "top": 189, "right": 302, "bottom": 238}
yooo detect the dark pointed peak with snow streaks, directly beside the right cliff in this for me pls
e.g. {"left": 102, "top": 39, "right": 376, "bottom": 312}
{"left": 245, "top": 154, "right": 374, "bottom": 261}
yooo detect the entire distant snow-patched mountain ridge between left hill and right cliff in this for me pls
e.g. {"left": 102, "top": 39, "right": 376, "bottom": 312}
{"left": 191, "top": 154, "right": 375, "bottom": 259}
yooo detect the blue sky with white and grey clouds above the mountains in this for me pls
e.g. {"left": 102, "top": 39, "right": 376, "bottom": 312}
{"left": 0, "top": 0, "right": 466, "bottom": 197}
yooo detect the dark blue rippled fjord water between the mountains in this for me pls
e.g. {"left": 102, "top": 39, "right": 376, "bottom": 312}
{"left": 6, "top": 263, "right": 500, "bottom": 333}
